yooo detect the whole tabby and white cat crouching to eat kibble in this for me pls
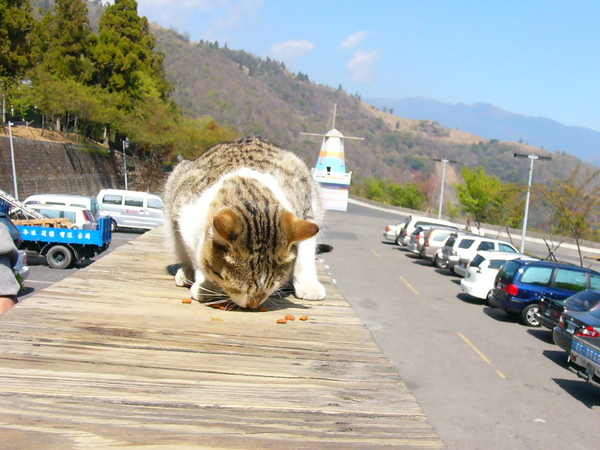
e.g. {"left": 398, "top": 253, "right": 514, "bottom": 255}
{"left": 164, "top": 138, "right": 325, "bottom": 308}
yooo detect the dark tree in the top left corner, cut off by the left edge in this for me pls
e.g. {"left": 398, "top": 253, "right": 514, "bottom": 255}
{"left": 0, "top": 0, "right": 34, "bottom": 78}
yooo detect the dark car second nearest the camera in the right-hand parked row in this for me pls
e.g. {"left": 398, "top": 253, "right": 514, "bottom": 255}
{"left": 552, "top": 310, "right": 600, "bottom": 353}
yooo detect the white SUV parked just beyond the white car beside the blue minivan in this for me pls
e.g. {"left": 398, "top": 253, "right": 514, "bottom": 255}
{"left": 441, "top": 234, "right": 518, "bottom": 274}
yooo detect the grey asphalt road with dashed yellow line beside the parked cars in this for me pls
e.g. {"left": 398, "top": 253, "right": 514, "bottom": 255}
{"left": 321, "top": 201, "right": 600, "bottom": 449}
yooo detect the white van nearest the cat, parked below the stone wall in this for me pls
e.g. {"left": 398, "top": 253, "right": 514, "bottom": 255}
{"left": 96, "top": 189, "right": 165, "bottom": 231}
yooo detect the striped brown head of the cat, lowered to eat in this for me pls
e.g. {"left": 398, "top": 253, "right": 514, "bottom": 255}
{"left": 202, "top": 209, "right": 319, "bottom": 308}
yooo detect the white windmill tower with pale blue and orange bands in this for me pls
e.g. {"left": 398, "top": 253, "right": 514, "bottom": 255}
{"left": 301, "top": 105, "right": 364, "bottom": 211}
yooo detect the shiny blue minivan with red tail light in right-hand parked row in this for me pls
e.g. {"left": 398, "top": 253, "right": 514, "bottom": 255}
{"left": 488, "top": 259, "right": 600, "bottom": 327}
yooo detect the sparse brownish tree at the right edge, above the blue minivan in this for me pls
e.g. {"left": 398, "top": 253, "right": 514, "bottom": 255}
{"left": 535, "top": 164, "right": 600, "bottom": 267}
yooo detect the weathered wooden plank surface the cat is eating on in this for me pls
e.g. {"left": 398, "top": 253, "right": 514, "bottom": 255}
{"left": 0, "top": 228, "right": 444, "bottom": 449}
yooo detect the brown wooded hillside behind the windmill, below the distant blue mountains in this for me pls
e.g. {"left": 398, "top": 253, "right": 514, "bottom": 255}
{"left": 153, "top": 26, "right": 596, "bottom": 193}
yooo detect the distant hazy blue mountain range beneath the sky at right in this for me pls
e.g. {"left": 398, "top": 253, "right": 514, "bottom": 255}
{"left": 364, "top": 97, "right": 600, "bottom": 166}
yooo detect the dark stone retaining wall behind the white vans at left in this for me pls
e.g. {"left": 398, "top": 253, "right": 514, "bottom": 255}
{"left": 0, "top": 136, "right": 122, "bottom": 200}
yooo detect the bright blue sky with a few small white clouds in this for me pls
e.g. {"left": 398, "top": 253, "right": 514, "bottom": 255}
{"left": 138, "top": 0, "right": 600, "bottom": 131}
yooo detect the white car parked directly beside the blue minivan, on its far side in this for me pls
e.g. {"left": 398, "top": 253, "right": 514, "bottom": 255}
{"left": 460, "top": 250, "right": 538, "bottom": 304}
